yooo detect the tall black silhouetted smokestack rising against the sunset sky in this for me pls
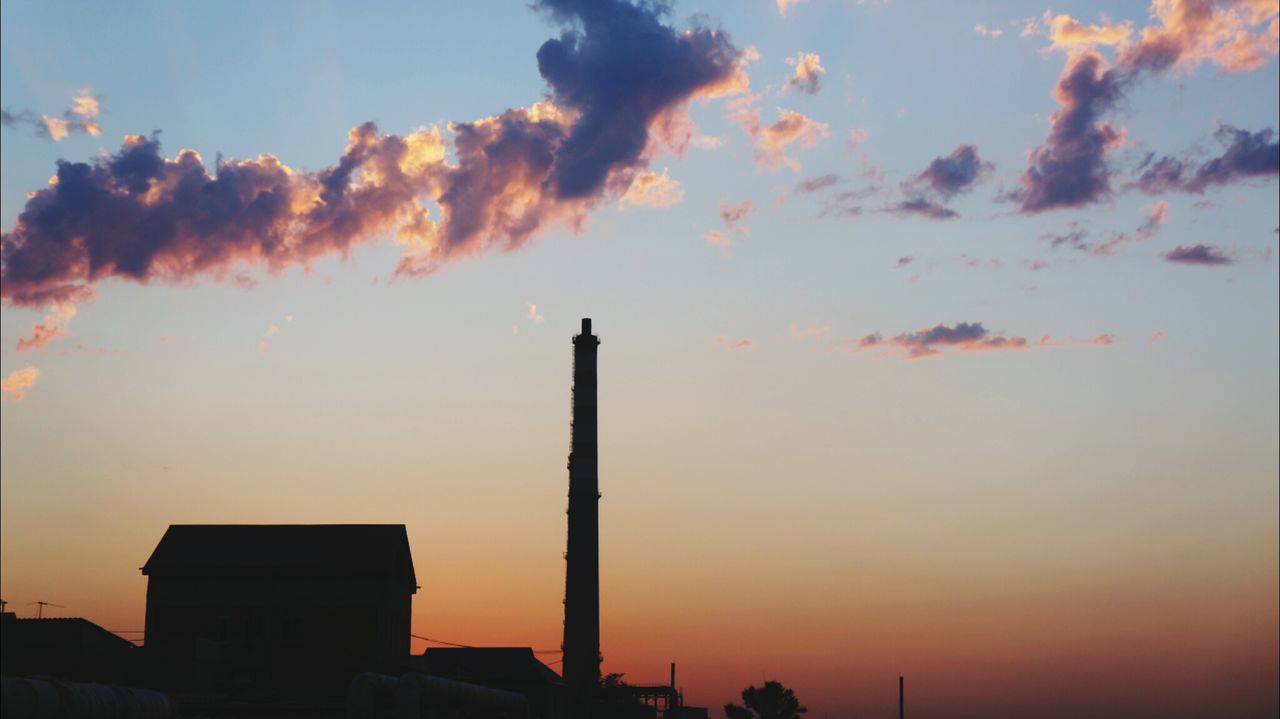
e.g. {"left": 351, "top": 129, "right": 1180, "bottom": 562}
{"left": 561, "top": 317, "right": 602, "bottom": 719}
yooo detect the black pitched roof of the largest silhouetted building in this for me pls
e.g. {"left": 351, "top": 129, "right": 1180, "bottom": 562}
{"left": 142, "top": 525, "right": 417, "bottom": 587}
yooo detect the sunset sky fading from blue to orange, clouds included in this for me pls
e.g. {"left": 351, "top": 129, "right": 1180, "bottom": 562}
{"left": 0, "top": 0, "right": 1280, "bottom": 719}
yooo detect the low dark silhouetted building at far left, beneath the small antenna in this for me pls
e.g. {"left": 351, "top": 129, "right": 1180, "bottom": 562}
{"left": 0, "top": 612, "right": 137, "bottom": 682}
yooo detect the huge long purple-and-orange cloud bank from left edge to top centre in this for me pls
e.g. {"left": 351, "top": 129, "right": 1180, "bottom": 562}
{"left": 0, "top": 0, "right": 748, "bottom": 306}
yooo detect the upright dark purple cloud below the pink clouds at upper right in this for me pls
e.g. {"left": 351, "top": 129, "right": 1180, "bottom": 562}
{"left": 1012, "top": 50, "right": 1124, "bottom": 214}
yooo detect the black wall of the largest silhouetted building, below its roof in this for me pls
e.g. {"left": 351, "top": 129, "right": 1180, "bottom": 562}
{"left": 146, "top": 572, "right": 412, "bottom": 693}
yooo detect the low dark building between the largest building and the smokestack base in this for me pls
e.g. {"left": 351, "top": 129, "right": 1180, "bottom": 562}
{"left": 422, "top": 647, "right": 564, "bottom": 719}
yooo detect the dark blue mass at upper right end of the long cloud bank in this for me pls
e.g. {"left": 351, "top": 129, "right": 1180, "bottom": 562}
{"left": 536, "top": 0, "right": 740, "bottom": 200}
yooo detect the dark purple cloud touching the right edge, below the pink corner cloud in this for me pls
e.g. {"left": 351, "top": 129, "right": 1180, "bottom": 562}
{"left": 1134, "top": 124, "right": 1280, "bottom": 194}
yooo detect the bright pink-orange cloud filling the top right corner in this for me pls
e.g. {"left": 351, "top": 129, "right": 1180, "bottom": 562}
{"left": 1119, "top": 0, "right": 1280, "bottom": 73}
